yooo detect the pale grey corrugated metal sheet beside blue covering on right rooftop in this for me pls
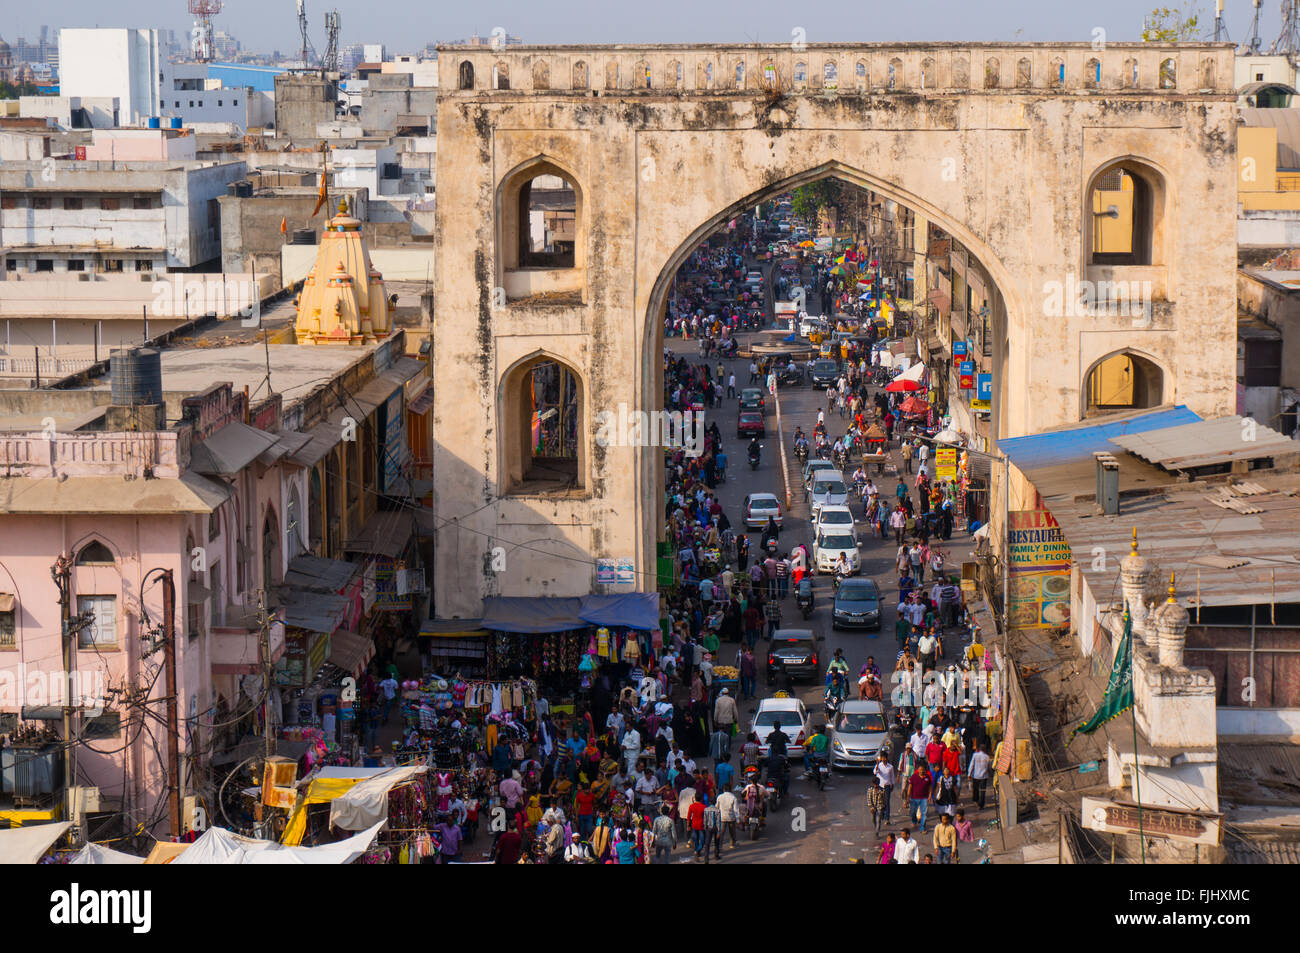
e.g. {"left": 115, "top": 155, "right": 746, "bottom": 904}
{"left": 1110, "top": 413, "right": 1300, "bottom": 469}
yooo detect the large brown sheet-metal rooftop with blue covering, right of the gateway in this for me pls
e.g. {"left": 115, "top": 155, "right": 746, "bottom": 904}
{"left": 1001, "top": 408, "right": 1300, "bottom": 608}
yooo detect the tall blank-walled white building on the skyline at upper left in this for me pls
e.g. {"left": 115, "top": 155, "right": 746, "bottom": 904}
{"left": 59, "top": 27, "right": 166, "bottom": 125}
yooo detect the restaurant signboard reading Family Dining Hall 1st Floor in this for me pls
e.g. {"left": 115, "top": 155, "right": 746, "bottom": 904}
{"left": 1008, "top": 510, "right": 1071, "bottom": 628}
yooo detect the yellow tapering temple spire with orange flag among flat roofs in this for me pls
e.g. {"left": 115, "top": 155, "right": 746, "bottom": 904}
{"left": 294, "top": 200, "right": 393, "bottom": 345}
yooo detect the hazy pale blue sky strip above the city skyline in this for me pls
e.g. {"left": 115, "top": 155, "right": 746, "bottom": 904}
{"left": 0, "top": 0, "right": 1281, "bottom": 52}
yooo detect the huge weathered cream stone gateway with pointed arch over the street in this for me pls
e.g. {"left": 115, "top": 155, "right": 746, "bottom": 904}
{"left": 433, "top": 43, "right": 1236, "bottom": 618}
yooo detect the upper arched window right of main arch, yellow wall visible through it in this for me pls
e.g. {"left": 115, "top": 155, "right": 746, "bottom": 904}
{"left": 1087, "top": 160, "right": 1167, "bottom": 265}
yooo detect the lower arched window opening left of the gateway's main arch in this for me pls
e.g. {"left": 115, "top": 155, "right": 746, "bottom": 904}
{"left": 501, "top": 355, "right": 586, "bottom": 494}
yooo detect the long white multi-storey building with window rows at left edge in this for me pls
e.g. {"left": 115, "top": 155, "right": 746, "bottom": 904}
{"left": 0, "top": 156, "right": 244, "bottom": 273}
